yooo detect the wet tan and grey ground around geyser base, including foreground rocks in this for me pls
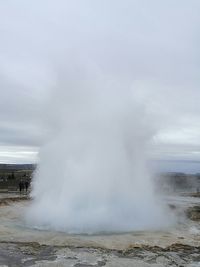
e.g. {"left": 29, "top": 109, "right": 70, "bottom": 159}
{"left": 0, "top": 194, "right": 200, "bottom": 267}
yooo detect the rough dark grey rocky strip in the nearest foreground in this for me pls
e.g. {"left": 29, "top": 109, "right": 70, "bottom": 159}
{"left": 0, "top": 242, "right": 200, "bottom": 267}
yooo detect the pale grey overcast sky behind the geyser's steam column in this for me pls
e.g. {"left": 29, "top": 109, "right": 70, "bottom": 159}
{"left": 0, "top": 0, "right": 200, "bottom": 173}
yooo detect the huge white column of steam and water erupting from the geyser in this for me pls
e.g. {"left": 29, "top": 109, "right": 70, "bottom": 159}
{"left": 28, "top": 67, "right": 170, "bottom": 233}
